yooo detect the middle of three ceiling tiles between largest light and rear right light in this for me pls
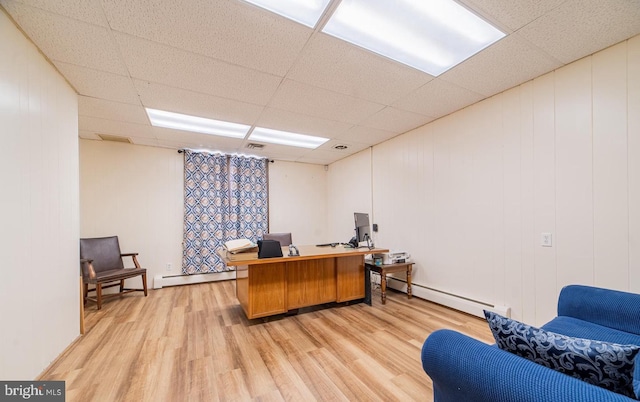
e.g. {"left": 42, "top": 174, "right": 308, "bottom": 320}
{"left": 269, "top": 80, "right": 384, "bottom": 124}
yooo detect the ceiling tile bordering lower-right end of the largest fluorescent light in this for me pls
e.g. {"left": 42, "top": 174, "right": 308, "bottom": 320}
{"left": 439, "top": 33, "right": 561, "bottom": 96}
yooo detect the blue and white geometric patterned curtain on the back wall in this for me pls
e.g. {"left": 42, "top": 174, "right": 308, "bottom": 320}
{"left": 182, "top": 150, "right": 268, "bottom": 274}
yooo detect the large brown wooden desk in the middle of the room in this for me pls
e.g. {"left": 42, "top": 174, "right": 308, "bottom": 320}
{"left": 224, "top": 246, "right": 388, "bottom": 319}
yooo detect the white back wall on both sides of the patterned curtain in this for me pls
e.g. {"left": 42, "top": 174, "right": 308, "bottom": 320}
{"left": 80, "top": 140, "right": 326, "bottom": 282}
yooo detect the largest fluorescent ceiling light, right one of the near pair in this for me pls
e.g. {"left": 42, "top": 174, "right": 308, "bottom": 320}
{"left": 322, "top": 0, "right": 505, "bottom": 76}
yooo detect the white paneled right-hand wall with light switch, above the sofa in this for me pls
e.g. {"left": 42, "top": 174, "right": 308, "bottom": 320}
{"left": 328, "top": 37, "right": 640, "bottom": 324}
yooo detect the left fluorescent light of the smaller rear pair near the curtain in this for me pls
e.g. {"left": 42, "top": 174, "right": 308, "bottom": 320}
{"left": 145, "top": 108, "right": 251, "bottom": 138}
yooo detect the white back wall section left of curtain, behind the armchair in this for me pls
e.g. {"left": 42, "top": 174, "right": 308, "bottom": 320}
{"left": 80, "top": 140, "right": 184, "bottom": 282}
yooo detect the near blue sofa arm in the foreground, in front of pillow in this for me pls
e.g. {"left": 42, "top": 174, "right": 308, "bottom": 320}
{"left": 422, "top": 329, "right": 633, "bottom": 402}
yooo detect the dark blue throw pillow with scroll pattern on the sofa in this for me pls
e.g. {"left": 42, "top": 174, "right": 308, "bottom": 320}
{"left": 484, "top": 310, "right": 640, "bottom": 399}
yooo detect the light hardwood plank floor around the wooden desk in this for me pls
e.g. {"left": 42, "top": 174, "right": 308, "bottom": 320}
{"left": 40, "top": 281, "right": 492, "bottom": 402}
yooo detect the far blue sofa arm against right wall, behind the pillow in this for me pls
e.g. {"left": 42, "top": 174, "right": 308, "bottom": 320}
{"left": 558, "top": 285, "right": 640, "bottom": 335}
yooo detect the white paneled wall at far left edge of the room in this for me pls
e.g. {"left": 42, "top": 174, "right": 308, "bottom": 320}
{"left": 0, "top": 9, "right": 80, "bottom": 380}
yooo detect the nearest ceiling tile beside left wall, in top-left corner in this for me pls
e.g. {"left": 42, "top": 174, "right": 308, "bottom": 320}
{"left": 2, "top": 2, "right": 127, "bottom": 75}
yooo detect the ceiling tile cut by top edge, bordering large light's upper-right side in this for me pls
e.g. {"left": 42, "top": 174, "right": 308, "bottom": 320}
{"left": 462, "top": 0, "right": 567, "bottom": 31}
